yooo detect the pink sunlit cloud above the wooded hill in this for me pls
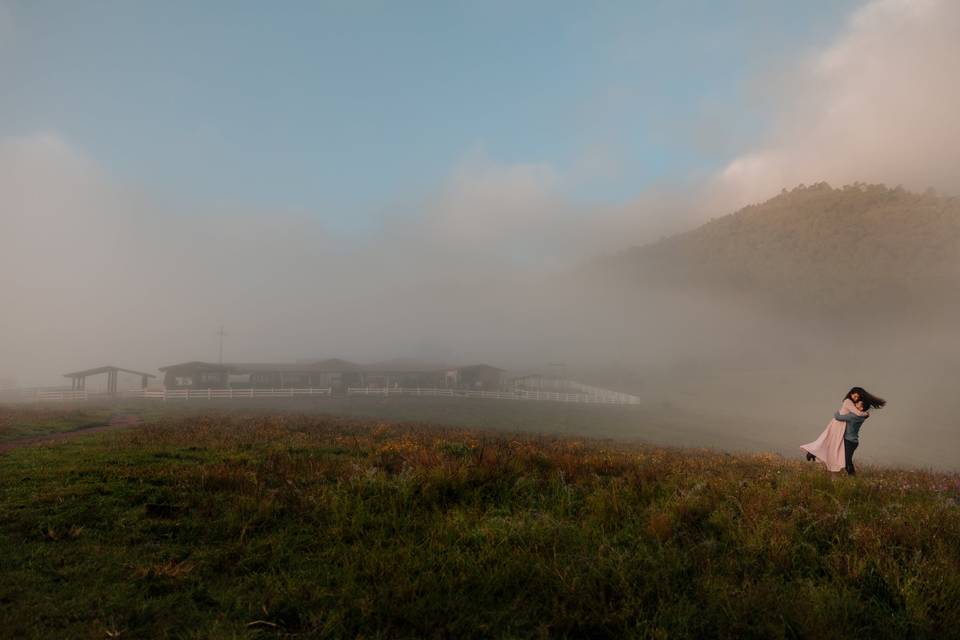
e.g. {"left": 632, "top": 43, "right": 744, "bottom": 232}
{"left": 706, "top": 0, "right": 960, "bottom": 209}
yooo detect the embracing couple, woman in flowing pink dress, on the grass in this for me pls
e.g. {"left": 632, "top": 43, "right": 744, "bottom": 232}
{"left": 800, "top": 387, "right": 887, "bottom": 476}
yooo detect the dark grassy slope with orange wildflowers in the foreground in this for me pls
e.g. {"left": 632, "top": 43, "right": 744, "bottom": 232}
{"left": 0, "top": 412, "right": 960, "bottom": 638}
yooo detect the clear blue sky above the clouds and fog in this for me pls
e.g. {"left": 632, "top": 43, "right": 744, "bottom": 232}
{"left": 0, "top": 0, "right": 859, "bottom": 229}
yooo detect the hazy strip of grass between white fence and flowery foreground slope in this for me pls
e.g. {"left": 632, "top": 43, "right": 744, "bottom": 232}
{"left": 0, "top": 390, "right": 960, "bottom": 472}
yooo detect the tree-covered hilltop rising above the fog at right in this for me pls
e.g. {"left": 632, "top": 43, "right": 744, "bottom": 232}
{"left": 596, "top": 183, "right": 960, "bottom": 314}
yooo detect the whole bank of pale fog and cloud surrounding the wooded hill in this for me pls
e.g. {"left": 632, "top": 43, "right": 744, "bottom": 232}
{"left": 0, "top": 0, "right": 960, "bottom": 467}
